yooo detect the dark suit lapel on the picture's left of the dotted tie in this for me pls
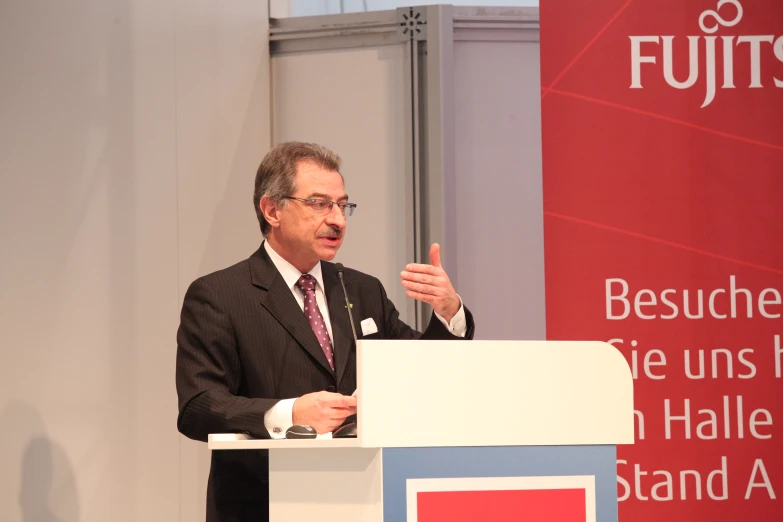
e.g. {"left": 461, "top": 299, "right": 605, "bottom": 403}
{"left": 250, "top": 245, "right": 332, "bottom": 373}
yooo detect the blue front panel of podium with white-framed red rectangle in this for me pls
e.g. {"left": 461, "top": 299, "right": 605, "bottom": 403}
{"left": 383, "top": 446, "right": 617, "bottom": 522}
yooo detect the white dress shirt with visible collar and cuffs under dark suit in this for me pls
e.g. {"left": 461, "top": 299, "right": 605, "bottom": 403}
{"left": 264, "top": 241, "right": 467, "bottom": 439}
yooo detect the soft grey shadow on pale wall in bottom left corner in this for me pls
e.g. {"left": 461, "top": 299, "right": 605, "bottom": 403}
{"left": 0, "top": 401, "right": 79, "bottom": 522}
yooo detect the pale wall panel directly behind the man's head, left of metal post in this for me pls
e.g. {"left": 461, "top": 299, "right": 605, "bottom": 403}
{"left": 272, "top": 44, "right": 413, "bottom": 324}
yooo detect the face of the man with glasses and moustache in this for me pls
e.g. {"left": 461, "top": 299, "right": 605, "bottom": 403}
{"left": 273, "top": 162, "right": 348, "bottom": 272}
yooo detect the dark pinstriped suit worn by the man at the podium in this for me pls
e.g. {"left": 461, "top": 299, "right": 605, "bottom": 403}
{"left": 176, "top": 245, "right": 474, "bottom": 522}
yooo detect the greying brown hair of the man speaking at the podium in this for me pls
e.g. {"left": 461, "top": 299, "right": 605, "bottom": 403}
{"left": 253, "top": 141, "right": 342, "bottom": 237}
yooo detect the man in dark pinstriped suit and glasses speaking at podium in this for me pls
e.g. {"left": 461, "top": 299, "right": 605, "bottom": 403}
{"left": 176, "top": 142, "right": 474, "bottom": 522}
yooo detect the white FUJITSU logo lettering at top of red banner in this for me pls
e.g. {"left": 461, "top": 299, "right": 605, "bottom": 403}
{"left": 630, "top": 0, "right": 783, "bottom": 108}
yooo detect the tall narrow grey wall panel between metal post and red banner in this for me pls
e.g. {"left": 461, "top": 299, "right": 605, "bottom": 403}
{"left": 446, "top": 41, "right": 546, "bottom": 339}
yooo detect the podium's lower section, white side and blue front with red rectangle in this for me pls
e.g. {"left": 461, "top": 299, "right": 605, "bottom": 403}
{"left": 258, "top": 440, "right": 617, "bottom": 522}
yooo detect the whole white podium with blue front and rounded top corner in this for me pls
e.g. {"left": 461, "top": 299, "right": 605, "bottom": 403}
{"left": 209, "top": 340, "right": 634, "bottom": 522}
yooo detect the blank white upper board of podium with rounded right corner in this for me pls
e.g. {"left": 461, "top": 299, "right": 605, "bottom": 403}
{"left": 356, "top": 339, "right": 634, "bottom": 448}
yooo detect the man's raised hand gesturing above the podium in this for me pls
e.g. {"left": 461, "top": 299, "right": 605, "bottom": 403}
{"left": 400, "top": 243, "right": 461, "bottom": 322}
